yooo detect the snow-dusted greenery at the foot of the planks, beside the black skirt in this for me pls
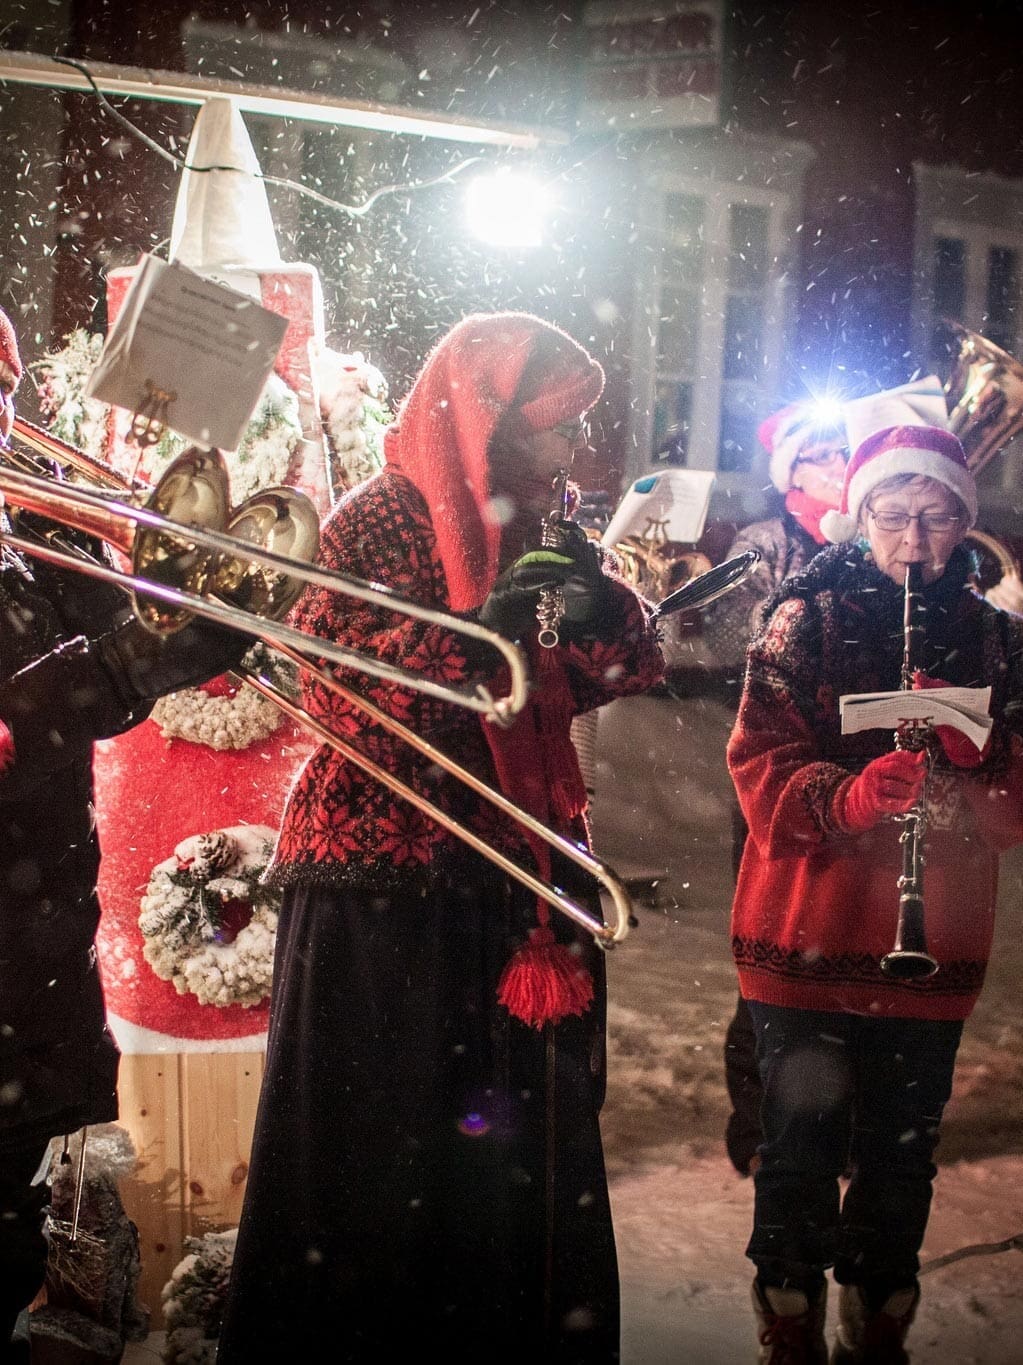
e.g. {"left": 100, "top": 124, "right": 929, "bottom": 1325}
{"left": 160, "top": 1227, "right": 238, "bottom": 1365}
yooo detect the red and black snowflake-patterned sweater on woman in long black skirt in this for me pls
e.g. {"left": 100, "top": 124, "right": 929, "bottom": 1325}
{"left": 268, "top": 470, "right": 664, "bottom": 889}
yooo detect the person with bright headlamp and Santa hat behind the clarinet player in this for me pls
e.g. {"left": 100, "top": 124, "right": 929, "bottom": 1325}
{"left": 702, "top": 403, "right": 848, "bottom": 1175}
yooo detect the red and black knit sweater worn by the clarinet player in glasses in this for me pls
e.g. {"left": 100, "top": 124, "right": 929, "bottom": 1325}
{"left": 728, "top": 546, "right": 1023, "bottom": 1020}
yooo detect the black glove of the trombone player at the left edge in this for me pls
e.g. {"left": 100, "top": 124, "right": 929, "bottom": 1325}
{"left": 96, "top": 616, "right": 254, "bottom": 704}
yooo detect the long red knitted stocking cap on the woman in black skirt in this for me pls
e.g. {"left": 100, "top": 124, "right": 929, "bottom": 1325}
{"left": 384, "top": 313, "right": 604, "bottom": 612}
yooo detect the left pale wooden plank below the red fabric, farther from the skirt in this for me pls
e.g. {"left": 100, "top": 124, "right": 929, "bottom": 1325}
{"left": 117, "top": 1054, "right": 186, "bottom": 1331}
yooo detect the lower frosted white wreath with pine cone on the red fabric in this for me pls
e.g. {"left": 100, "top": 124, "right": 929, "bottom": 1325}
{"left": 138, "top": 824, "right": 280, "bottom": 1006}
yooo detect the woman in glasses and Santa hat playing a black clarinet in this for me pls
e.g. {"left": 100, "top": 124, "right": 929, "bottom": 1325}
{"left": 728, "top": 426, "right": 1023, "bottom": 1365}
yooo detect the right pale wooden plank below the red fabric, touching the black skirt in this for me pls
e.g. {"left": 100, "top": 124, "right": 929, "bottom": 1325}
{"left": 182, "top": 1052, "right": 264, "bottom": 1237}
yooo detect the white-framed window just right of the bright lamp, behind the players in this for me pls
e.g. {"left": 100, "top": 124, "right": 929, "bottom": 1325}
{"left": 628, "top": 138, "right": 806, "bottom": 487}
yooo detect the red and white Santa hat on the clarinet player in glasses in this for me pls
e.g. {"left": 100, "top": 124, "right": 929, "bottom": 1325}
{"left": 821, "top": 426, "right": 977, "bottom": 545}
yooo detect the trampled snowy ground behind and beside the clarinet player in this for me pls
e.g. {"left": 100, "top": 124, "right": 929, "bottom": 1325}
{"left": 124, "top": 698, "right": 1023, "bottom": 1365}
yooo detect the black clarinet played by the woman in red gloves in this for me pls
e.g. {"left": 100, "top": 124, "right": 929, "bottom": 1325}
{"left": 881, "top": 564, "right": 938, "bottom": 981}
